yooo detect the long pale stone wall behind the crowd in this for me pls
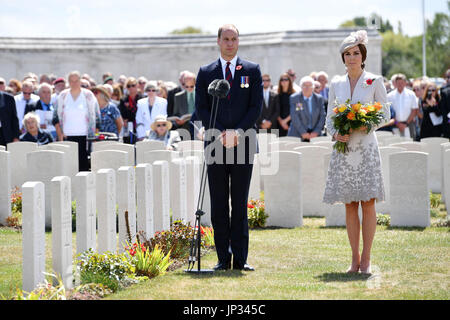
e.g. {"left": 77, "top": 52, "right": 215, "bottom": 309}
{"left": 0, "top": 29, "right": 382, "bottom": 83}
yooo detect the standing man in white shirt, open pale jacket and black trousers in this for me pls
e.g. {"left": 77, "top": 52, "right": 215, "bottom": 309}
{"left": 53, "top": 71, "right": 100, "bottom": 171}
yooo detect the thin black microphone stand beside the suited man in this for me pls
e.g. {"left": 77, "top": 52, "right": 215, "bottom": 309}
{"left": 184, "top": 90, "right": 220, "bottom": 274}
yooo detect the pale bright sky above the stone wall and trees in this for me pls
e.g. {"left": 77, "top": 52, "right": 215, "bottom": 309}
{"left": 0, "top": 0, "right": 448, "bottom": 37}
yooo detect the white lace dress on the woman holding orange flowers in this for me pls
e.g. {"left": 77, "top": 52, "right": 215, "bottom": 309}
{"left": 323, "top": 71, "right": 390, "bottom": 204}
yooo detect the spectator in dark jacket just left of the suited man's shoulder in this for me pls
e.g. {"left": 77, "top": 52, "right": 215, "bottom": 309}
{"left": 173, "top": 72, "right": 196, "bottom": 130}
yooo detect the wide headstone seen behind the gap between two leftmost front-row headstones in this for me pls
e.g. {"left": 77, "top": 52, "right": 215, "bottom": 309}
{"left": 27, "top": 150, "right": 67, "bottom": 228}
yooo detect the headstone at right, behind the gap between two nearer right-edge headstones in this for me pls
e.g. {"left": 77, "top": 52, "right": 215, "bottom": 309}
{"left": 420, "top": 138, "right": 449, "bottom": 193}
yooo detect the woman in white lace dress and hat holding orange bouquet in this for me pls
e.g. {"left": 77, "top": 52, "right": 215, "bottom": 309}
{"left": 323, "top": 30, "right": 390, "bottom": 273}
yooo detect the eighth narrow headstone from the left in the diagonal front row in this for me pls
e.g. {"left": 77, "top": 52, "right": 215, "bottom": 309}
{"left": 169, "top": 158, "right": 187, "bottom": 222}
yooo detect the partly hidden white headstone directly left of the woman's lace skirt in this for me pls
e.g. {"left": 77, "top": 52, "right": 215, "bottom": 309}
{"left": 294, "top": 146, "right": 330, "bottom": 217}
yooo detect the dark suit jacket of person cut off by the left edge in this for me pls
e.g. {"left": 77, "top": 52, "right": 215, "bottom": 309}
{"left": 0, "top": 92, "right": 20, "bottom": 146}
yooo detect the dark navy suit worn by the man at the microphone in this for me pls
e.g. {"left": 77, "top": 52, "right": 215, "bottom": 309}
{"left": 195, "top": 57, "right": 263, "bottom": 268}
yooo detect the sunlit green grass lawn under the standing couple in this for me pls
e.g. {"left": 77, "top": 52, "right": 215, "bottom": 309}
{"left": 0, "top": 218, "right": 450, "bottom": 300}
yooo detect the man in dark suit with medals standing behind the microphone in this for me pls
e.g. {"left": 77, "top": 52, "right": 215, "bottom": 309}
{"left": 195, "top": 25, "right": 263, "bottom": 271}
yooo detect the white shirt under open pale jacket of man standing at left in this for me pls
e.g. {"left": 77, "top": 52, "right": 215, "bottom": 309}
{"left": 64, "top": 93, "right": 88, "bottom": 136}
